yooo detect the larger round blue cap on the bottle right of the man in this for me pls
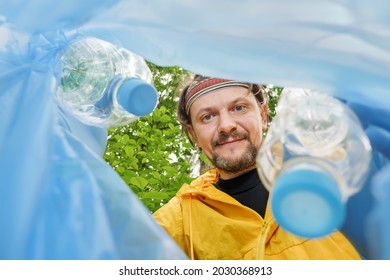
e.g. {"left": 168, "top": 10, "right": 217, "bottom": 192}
{"left": 271, "top": 166, "right": 345, "bottom": 238}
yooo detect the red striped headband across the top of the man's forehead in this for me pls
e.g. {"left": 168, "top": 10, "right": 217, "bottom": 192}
{"left": 185, "top": 78, "right": 249, "bottom": 115}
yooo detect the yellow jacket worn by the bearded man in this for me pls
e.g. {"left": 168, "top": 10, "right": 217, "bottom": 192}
{"left": 154, "top": 169, "right": 360, "bottom": 260}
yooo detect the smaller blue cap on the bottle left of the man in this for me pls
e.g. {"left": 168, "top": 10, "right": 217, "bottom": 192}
{"left": 117, "top": 78, "right": 158, "bottom": 116}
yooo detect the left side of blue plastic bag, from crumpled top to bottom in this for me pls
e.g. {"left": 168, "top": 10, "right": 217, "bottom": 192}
{"left": 0, "top": 25, "right": 186, "bottom": 259}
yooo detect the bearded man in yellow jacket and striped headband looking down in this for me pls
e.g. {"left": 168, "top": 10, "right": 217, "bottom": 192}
{"left": 154, "top": 75, "right": 359, "bottom": 260}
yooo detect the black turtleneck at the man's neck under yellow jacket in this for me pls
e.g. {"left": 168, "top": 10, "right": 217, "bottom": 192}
{"left": 215, "top": 168, "right": 268, "bottom": 218}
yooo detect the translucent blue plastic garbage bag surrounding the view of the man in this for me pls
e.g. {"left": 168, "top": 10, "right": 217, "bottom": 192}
{"left": 0, "top": 0, "right": 390, "bottom": 259}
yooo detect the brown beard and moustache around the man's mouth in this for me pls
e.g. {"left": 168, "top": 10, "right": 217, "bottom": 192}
{"left": 210, "top": 131, "right": 257, "bottom": 173}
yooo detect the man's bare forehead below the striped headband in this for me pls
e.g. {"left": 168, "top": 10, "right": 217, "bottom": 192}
{"left": 190, "top": 87, "right": 256, "bottom": 113}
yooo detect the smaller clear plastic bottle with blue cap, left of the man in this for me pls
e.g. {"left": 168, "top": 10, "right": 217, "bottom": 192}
{"left": 56, "top": 37, "right": 158, "bottom": 127}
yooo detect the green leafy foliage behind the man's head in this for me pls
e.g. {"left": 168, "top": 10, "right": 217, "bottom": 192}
{"left": 104, "top": 63, "right": 281, "bottom": 212}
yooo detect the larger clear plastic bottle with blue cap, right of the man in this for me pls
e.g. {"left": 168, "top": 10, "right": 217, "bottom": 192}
{"left": 257, "top": 89, "right": 371, "bottom": 238}
